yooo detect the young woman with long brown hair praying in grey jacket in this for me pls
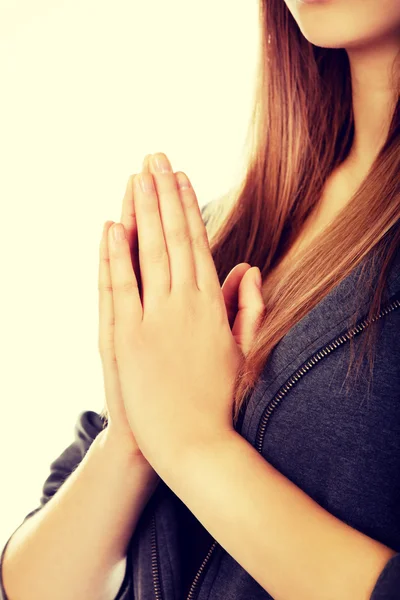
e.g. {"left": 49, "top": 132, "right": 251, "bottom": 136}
{"left": 1, "top": 0, "right": 400, "bottom": 600}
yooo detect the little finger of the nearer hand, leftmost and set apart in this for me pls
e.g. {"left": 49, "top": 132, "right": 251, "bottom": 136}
{"left": 107, "top": 223, "right": 143, "bottom": 341}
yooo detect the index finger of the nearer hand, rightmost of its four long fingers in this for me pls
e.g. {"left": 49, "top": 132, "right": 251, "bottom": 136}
{"left": 176, "top": 171, "right": 222, "bottom": 298}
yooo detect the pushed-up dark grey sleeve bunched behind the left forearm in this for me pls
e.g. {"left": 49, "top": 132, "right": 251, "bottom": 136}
{"left": 0, "top": 410, "right": 132, "bottom": 600}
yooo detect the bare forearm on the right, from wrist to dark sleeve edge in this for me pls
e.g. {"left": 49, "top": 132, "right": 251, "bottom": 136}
{"left": 165, "top": 433, "right": 395, "bottom": 600}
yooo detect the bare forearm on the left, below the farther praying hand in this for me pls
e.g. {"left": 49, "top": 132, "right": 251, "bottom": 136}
{"left": 3, "top": 430, "right": 158, "bottom": 600}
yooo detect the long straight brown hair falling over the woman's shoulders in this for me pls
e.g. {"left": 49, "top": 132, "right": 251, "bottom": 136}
{"left": 98, "top": 0, "right": 400, "bottom": 432}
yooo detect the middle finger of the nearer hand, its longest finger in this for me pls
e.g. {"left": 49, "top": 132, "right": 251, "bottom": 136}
{"left": 150, "top": 152, "right": 196, "bottom": 290}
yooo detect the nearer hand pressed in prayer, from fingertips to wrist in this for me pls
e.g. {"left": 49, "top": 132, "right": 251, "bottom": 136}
{"left": 98, "top": 155, "right": 264, "bottom": 470}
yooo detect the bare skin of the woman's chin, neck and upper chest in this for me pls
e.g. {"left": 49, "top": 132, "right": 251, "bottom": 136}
{"left": 274, "top": 0, "right": 400, "bottom": 289}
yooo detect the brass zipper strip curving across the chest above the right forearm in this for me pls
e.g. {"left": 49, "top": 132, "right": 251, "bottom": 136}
{"left": 256, "top": 300, "right": 400, "bottom": 454}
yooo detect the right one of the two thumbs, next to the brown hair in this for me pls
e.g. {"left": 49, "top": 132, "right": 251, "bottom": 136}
{"left": 232, "top": 267, "right": 265, "bottom": 355}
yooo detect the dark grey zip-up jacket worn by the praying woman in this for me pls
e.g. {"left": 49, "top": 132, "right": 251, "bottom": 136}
{"left": 0, "top": 207, "right": 400, "bottom": 600}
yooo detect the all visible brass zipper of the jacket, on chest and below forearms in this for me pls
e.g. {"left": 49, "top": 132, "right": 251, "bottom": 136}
{"left": 151, "top": 300, "right": 400, "bottom": 600}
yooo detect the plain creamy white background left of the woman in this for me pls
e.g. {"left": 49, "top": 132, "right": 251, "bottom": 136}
{"left": 0, "top": 0, "right": 259, "bottom": 549}
